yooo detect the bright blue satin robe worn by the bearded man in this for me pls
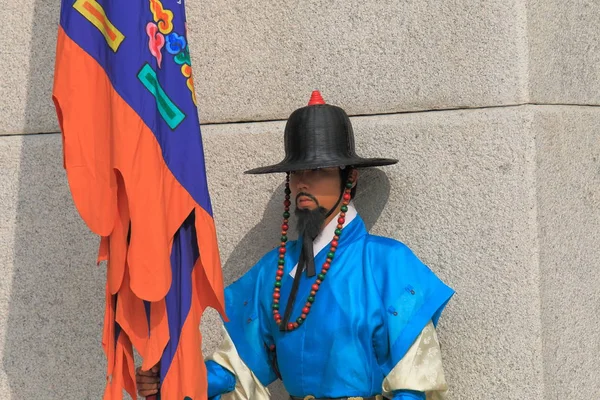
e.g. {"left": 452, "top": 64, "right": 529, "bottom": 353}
{"left": 209, "top": 216, "right": 454, "bottom": 399}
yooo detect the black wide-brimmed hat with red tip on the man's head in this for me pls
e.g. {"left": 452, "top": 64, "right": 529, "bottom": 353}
{"left": 245, "top": 90, "right": 398, "bottom": 174}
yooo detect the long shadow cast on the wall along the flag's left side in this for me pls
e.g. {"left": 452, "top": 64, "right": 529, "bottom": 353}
{"left": 0, "top": 0, "right": 106, "bottom": 400}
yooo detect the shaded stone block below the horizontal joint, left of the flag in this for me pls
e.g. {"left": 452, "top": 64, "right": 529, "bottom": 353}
{"left": 0, "top": 135, "right": 106, "bottom": 400}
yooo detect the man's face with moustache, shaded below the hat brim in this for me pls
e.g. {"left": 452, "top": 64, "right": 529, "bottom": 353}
{"left": 290, "top": 168, "right": 354, "bottom": 215}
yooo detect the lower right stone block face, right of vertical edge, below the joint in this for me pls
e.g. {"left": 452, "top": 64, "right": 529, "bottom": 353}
{"left": 533, "top": 107, "right": 600, "bottom": 399}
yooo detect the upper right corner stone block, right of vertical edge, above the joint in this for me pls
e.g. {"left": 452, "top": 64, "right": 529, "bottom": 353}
{"left": 527, "top": 0, "right": 600, "bottom": 105}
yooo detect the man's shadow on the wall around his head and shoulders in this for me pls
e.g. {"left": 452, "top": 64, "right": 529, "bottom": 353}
{"left": 223, "top": 168, "right": 390, "bottom": 399}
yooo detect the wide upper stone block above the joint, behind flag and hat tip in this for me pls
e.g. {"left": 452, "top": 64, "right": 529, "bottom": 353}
{"left": 5, "top": 0, "right": 528, "bottom": 134}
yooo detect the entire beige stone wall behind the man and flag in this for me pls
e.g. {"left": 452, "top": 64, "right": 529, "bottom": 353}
{"left": 0, "top": 0, "right": 600, "bottom": 400}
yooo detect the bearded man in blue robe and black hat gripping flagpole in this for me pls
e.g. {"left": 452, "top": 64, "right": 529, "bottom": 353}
{"left": 138, "top": 91, "right": 454, "bottom": 400}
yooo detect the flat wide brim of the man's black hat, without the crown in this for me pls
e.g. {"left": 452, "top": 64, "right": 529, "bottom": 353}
{"left": 244, "top": 157, "right": 398, "bottom": 175}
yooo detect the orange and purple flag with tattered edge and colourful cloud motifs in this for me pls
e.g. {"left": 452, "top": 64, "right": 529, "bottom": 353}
{"left": 53, "top": 0, "right": 225, "bottom": 400}
